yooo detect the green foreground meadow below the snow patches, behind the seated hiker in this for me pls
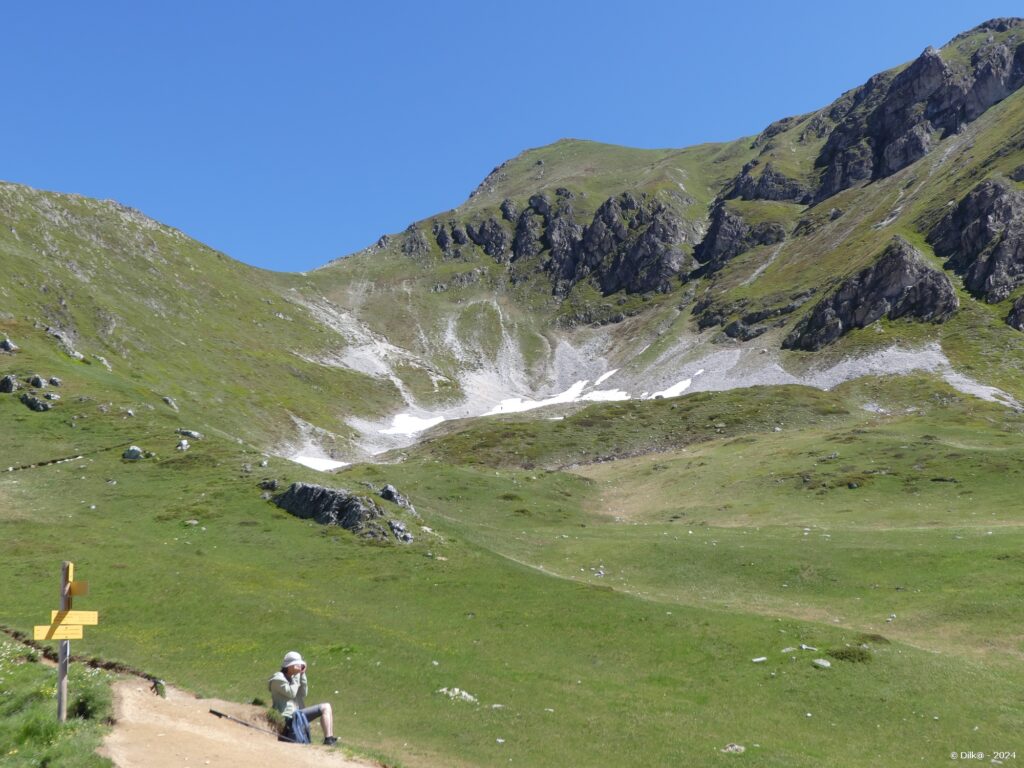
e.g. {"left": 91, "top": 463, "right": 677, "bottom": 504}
{"left": 0, "top": 380, "right": 1024, "bottom": 766}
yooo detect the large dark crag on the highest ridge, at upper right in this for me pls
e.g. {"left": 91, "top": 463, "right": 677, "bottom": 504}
{"left": 815, "top": 33, "right": 1024, "bottom": 201}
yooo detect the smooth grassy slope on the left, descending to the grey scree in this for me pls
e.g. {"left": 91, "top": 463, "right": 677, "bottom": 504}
{"left": 0, "top": 184, "right": 397, "bottom": 445}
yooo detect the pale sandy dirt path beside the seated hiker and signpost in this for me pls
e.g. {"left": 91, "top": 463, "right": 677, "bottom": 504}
{"left": 99, "top": 678, "right": 373, "bottom": 768}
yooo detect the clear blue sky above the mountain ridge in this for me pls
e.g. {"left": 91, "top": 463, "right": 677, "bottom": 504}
{"left": 0, "top": 0, "right": 1024, "bottom": 270}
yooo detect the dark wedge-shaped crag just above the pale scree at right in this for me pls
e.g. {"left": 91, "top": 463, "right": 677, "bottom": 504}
{"left": 782, "top": 238, "right": 959, "bottom": 352}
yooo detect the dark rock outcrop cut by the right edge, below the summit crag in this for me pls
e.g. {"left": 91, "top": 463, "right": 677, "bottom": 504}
{"left": 928, "top": 179, "right": 1024, "bottom": 303}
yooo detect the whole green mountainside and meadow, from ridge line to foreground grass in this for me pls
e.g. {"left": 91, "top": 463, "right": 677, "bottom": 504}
{"left": 0, "top": 13, "right": 1024, "bottom": 768}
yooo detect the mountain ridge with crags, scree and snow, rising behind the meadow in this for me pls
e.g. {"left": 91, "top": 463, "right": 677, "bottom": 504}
{"left": 0, "top": 19, "right": 1024, "bottom": 460}
